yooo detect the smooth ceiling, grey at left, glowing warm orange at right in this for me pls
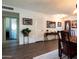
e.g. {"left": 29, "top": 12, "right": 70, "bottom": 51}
{"left": 2, "top": 0, "right": 76, "bottom": 14}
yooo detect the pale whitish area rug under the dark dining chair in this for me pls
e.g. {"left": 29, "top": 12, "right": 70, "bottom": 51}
{"left": 33, "top": 49, "right": 77, "bottom": 59}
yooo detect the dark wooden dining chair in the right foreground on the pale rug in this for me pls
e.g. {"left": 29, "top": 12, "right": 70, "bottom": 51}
{"left": 58, "top": 31, "right": 77, "bottom": 59}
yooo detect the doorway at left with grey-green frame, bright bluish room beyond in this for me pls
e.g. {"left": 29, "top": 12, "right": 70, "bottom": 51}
{"left": 2, "top": 11, "right": 19, "bottom": 48}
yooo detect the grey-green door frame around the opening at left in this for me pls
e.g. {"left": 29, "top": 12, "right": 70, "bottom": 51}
{"left": 2, "top": 11, "right": 19, "bottom": 45}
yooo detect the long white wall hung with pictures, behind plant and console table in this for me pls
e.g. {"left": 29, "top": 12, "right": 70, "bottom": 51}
{"left": 2, "top": 5, "right": 72, "bottom": 44}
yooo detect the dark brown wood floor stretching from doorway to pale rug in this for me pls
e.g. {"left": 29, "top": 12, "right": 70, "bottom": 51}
{"left": 2, "top": 40, "right": 58, "bottom": 59}
